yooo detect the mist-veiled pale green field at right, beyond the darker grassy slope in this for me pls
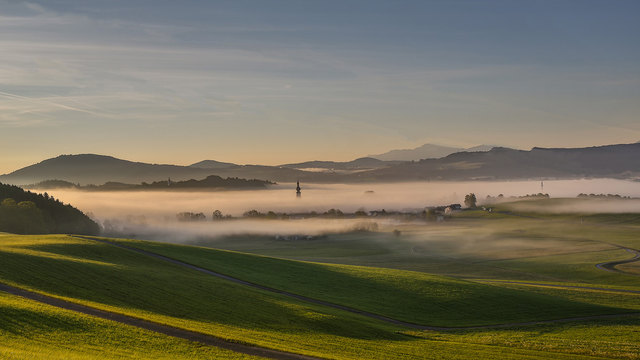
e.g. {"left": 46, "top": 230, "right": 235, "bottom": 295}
{"left": 180, "top": 204, "right": 640, "bottom": 288}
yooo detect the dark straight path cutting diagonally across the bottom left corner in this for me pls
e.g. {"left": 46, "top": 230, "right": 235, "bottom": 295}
{"left": 0, "top": 283, "right": 320, "bottom": 360}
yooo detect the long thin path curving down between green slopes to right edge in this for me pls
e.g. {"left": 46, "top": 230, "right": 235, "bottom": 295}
{"left": 74, "top": 236, "right": 640, "bottom": 331}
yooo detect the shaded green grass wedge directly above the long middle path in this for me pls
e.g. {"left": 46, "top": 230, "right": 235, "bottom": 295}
{"left": 116, "top": 235, "right": 624, "bottom": 326}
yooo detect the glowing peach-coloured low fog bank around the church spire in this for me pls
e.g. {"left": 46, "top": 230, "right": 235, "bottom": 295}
{"left": 38, "top": 179, "right": 640, "bottom": 241}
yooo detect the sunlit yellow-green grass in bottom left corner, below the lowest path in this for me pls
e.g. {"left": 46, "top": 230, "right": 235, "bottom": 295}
{"left": 0, "top": 292, "right": 259, "bottom": 360}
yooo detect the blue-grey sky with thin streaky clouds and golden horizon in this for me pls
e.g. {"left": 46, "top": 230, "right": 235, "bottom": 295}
{"left": 0, "top": 0, "right": 640, "bottom": 174}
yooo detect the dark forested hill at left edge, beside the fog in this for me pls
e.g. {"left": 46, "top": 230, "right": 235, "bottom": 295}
{"left": 0, "top": 183, "right": 100, "bottom": 235}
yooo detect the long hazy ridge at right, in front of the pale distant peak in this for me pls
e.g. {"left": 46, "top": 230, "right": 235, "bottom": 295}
{"left": 354, "top": 143, "right": 640, "bottom": 181}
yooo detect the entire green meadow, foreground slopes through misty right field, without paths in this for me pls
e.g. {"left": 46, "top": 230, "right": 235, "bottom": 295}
{"left": 0, "top": 198, "right": 640, "bottom": 359}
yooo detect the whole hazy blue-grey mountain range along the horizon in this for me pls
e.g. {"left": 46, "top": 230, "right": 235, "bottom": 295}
{"left": 0, "top": 143, "right": 640, "bottom": 185}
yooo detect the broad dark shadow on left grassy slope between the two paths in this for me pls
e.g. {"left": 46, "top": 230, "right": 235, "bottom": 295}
{"left": 0, "top": 242, "right": 406, "bottom": 340}
